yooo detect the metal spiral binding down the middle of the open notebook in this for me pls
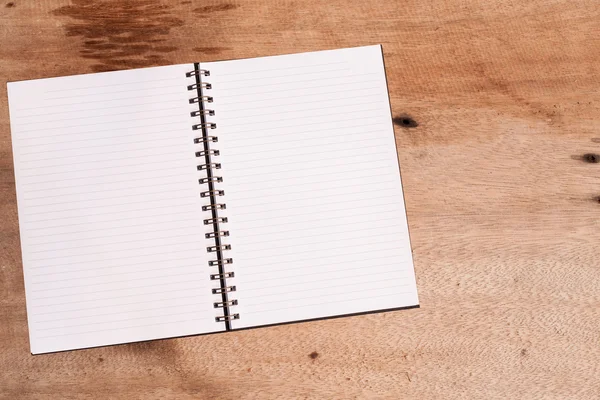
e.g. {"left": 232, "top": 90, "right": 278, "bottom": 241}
{"left": 190, "top": 63, "right": 240, "bottom": 330}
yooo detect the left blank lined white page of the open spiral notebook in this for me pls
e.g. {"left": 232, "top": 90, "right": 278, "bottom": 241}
{"left": 8, "top": 65, "right": 224, "bottom": 353}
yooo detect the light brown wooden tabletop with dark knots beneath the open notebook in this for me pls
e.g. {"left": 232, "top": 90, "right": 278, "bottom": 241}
{"left": 0, "top": 0, "right": 600, "bottom": 400}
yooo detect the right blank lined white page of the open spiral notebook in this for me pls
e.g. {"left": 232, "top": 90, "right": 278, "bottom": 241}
{"left": 202, "top": 46, "right": 418, "bottom": 328}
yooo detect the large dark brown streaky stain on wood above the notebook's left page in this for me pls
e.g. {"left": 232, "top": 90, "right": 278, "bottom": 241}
{"left": 52, "top": 0, "right": 184, "bottom": 72}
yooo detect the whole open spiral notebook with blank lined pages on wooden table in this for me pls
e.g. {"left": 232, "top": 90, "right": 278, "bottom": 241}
{"left": 8, "top": 46, "right": 418, "bottom": 354}
